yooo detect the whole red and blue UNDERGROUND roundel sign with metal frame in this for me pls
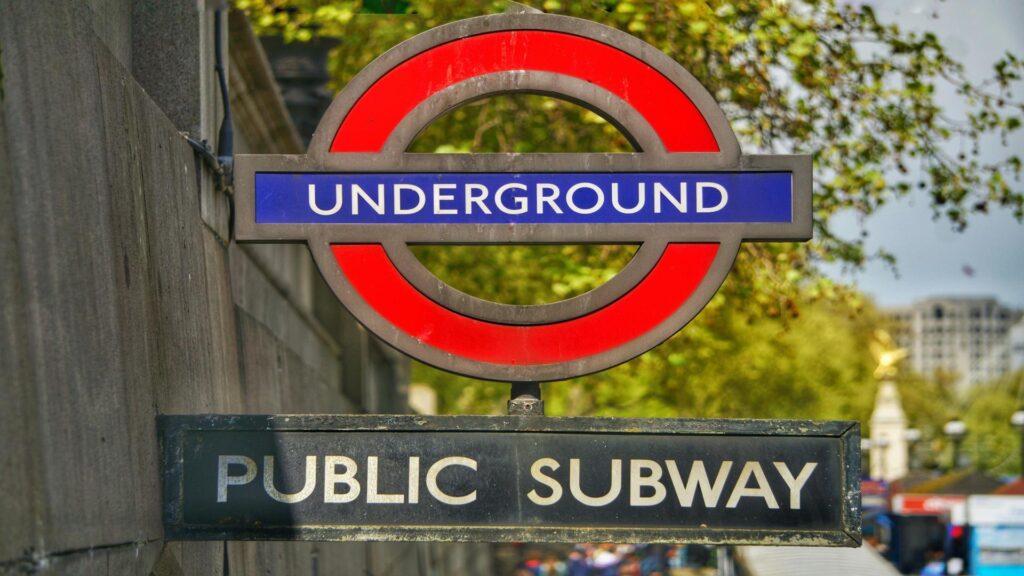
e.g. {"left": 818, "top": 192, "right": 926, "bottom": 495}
{"left": 236, "top": 13, "right": 811, "bottom": 381}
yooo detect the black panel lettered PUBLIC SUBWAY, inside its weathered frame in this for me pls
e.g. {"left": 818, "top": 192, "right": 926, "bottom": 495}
{"left": 180, "top": 430, "right": 845, "bottom": 530}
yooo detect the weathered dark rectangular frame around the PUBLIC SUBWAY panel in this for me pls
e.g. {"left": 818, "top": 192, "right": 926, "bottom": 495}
{"left": 159, "top": 415, "right": 861, "bottom": 547}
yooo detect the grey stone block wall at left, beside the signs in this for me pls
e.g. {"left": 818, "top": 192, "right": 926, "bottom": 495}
{"left": 0, "top": 0, "right": 466, "bottom": 576}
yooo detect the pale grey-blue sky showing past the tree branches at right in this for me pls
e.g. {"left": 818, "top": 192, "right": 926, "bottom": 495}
{"left": 826, "top": 0, "right": 1024, "bottom": 308}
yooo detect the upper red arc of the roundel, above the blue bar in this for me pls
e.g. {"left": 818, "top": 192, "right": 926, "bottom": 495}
{"left": 331, "top": 30, "right": 719, "bottom": 153}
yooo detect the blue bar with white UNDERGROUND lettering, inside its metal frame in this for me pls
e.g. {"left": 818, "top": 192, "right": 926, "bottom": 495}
{"left": 256, "top": 172, "right": 793, "bottom": 224}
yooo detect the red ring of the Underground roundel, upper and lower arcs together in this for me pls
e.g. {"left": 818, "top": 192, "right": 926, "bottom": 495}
{"left": 331, "top": 30, "right": 719, "bottom": 365}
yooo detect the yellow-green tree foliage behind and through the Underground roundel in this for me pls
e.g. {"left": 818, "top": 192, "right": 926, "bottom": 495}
{"left": 236, "top": 0, "right": 1024, "bottom": 419}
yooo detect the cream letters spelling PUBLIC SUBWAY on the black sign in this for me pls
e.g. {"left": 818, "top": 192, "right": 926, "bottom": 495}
{"left": 217, "top": 455, "right": 817, "bottom": 510}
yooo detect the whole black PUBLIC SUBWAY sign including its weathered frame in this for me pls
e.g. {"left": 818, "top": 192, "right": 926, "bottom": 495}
{"left": 160, "top": 416, "right": 860, "bottom": 546}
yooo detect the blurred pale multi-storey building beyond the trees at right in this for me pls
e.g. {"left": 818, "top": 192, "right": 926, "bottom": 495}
{"left": 884, "top": 296, "right": 1024, "bottom": 390}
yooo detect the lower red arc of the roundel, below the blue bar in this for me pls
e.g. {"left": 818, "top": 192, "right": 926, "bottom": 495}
{"left": 331, "top": 244, "right": 719, "bottom": 366}
